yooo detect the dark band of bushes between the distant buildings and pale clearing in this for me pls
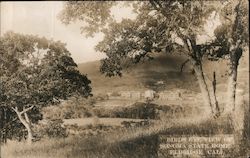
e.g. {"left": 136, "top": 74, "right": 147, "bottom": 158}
{"left": 93, "top": 102, "right": 190, "bottom": 119}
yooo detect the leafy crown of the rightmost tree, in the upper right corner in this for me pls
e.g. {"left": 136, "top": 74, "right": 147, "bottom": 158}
{"left": 209, "top": 0, "right": 249, "bottom": 60}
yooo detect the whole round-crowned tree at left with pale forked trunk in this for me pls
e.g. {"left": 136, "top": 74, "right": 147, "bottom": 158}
{"left": 0, "top": 32, "right": 91, "bottom": 143}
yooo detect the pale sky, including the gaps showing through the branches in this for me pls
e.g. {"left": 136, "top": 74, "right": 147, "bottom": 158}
{"left": 0, "top": 1, "right": 219, "bottom": 63}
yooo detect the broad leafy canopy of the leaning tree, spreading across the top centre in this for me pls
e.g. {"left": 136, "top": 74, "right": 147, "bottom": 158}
{"left": 59, "top": 0, "right": 225, "bottom": 76}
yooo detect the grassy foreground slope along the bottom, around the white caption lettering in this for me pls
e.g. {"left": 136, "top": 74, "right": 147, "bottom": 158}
{"left": 2, "top": 111, "right": 244, "bottom": 158}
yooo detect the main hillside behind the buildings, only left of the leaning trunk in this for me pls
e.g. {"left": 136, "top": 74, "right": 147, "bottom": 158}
{"left": 78, "top": 55, "right": 198, "bottom": 94}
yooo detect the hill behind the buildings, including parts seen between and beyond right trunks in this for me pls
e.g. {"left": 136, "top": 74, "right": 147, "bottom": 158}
{"left": 78, "top": 52, "right": 249, "bottom": 94}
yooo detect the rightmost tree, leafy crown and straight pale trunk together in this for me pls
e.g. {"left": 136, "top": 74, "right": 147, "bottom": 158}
{"left": 217, "top": 0, "right": 249, "bottom": 112}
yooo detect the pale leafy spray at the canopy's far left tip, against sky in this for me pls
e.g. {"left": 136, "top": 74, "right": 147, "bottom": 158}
{"left": 59, "top": 1, "right": 117, "bottom": 36}
